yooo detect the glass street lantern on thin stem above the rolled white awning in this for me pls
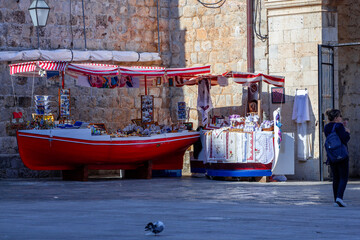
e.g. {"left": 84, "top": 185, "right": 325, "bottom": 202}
{"left": 28, "top": 0, "right": 50, "bottom": 49}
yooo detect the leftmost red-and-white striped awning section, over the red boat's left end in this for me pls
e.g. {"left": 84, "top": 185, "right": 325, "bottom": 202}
{"left": 9, "top": 61, "right": 66, "bottom": 77}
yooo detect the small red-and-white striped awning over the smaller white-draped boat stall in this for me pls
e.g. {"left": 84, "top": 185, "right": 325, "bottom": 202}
{"left": 223, "top": 71, "right": 285, "bottom": 87}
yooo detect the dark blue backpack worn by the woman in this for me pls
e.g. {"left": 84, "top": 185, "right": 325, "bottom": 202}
{"left": 325, "top": 123, "right": 349, "bottom": 163}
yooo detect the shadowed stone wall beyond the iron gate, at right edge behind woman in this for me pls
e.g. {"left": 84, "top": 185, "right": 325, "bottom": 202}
{"left": 337, "top": 0, "right": 360, "bottom": 177}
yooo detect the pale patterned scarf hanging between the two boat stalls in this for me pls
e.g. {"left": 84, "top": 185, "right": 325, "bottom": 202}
{"left": 197, "top": 79, "right": 213, "bottom": 126}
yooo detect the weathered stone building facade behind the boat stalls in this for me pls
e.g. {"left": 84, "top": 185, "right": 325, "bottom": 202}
{"left": 0, "top": 0, "right": 360, "bottom": 180}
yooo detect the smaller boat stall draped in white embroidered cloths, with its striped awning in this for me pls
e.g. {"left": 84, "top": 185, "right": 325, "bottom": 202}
{"left": 190, "top": 72, "right": 292, "bottom": 178}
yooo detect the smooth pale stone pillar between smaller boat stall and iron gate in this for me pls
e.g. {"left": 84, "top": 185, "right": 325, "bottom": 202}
{"left": 265, "top": 0, "right": 337, "bottom": 180}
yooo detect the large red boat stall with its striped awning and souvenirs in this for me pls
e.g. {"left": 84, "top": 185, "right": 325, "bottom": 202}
{"left": 10, "top": 61, "right": 210, "bottom": 180}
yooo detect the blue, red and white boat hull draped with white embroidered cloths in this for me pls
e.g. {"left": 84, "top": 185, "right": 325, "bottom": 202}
{"left": 191, "top": 111, "right": 279, "bottom": 177}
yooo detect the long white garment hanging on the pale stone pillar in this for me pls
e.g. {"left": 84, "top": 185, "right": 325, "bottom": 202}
{"left": 292, "top": 90, "right": 311, "bottom": 160}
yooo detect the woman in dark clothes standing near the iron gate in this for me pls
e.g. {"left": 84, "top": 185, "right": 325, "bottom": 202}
{"left": 324, "top": 109, "right": 350, "bottom": 207}
